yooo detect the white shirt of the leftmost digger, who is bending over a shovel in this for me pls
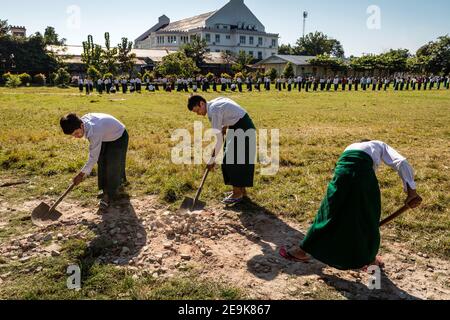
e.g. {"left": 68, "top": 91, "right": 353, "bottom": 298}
{"left": 81, "top": 113, "right": 125, "bottom": 176}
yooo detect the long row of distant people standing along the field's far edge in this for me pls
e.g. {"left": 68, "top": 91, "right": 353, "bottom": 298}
{"left": 79, "top": 76, "right": 450, "bottom": 94}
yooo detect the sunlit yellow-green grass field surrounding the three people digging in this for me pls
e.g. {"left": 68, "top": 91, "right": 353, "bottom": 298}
{"left": 0, "top": 88, "right": 450, "bottom": 298}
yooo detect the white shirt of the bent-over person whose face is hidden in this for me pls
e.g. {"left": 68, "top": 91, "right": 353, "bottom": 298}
{"left": 345, "top": 141, "right": 416, "bottom": 192}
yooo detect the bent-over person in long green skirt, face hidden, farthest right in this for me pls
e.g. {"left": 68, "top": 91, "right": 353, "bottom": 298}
{"left": 280, "top": 140, "right": 422, "bottom": 270}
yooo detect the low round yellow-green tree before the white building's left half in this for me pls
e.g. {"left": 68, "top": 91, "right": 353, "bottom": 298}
{"left": 156, "top": 51, "right": 200, "bottom": 78}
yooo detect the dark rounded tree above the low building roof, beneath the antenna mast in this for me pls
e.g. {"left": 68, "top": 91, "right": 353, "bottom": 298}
{"left": 293, "top": 32, "right": 344, "bottom": 58}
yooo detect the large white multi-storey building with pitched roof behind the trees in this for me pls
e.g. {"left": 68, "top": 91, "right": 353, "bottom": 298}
{"left": 135, "top": 0, "right": 278, "bottom": 60}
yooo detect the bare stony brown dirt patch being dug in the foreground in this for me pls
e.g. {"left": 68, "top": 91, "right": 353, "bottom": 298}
{"left": 0, "top": 197, "right": 450, "bottom": 299}
